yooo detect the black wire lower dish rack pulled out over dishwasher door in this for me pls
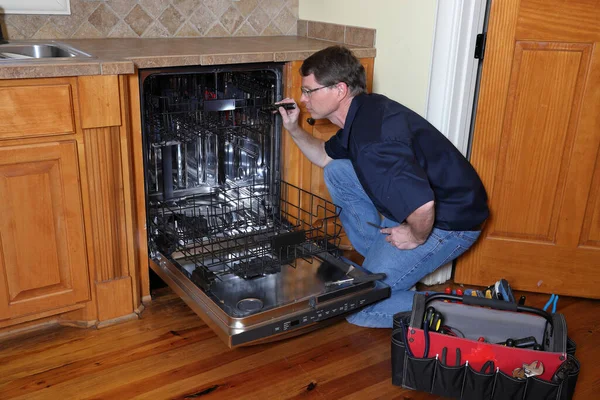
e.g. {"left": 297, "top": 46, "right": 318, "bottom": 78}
{"left": 148, "top": 181, "right": 342, "bottom": 290}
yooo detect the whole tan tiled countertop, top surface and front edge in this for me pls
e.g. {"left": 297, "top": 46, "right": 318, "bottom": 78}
{"left": 0, "top": 36, "right": 375, "bottom": 79}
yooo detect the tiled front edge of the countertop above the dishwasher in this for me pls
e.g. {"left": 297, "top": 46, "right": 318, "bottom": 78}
{"left": 0, "top": 47, "right": 376, "bottom": 79}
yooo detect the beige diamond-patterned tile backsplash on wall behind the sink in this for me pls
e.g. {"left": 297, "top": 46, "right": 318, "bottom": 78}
{"left": 0, "top": 0, "right": 299, "bottom": 40}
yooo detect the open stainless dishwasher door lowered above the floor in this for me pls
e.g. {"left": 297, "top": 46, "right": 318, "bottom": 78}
{"left": 150, "top": 253, "right": 390, "bottom": 348}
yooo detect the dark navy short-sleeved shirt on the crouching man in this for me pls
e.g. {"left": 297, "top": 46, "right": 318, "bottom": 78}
{"left": 325, "top": 94, "right": 489, "bottom": 231}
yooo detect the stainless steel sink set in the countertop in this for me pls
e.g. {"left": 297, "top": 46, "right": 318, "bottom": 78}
{"left": 0, "top": 41, "right": 91, "bottom": 61}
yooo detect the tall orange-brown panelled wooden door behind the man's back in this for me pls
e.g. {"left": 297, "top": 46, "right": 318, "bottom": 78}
{"left": 455, "top": 0, "right": 600, "bottom": 298}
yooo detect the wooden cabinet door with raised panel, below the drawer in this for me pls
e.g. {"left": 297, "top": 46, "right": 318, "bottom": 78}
{"left": 0, "top": 141, "right": 89, "bottom": 319}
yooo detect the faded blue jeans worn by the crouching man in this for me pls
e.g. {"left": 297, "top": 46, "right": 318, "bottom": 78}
{"left": 324, "top": 160, "right": 480, "bottom": 328}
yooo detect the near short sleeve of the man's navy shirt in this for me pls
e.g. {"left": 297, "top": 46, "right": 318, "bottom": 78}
{"left": 360, "top": 139, "right": 434, "bottom": 223}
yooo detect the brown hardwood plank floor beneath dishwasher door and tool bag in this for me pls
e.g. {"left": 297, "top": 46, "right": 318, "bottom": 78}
{"left": 0, "top": 285, "right": 600, "bottom": 400}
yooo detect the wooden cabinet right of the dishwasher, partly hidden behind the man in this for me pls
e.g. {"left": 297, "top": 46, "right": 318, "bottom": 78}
{"left": 282, "top": 58, "right": 374, "bottom": 249}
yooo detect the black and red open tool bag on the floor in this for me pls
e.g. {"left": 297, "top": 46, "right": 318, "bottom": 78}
{"left": 392, "top": 294, "right": 580, "bottom": 400}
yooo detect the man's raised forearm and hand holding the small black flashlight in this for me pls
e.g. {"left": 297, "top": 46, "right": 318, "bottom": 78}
{"left": 279, "top": 99, "right": 331, "bottom": 168}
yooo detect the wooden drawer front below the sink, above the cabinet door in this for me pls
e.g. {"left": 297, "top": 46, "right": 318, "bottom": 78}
{"left": 0, "top": 83, "right": 75, "bottom": 139}
